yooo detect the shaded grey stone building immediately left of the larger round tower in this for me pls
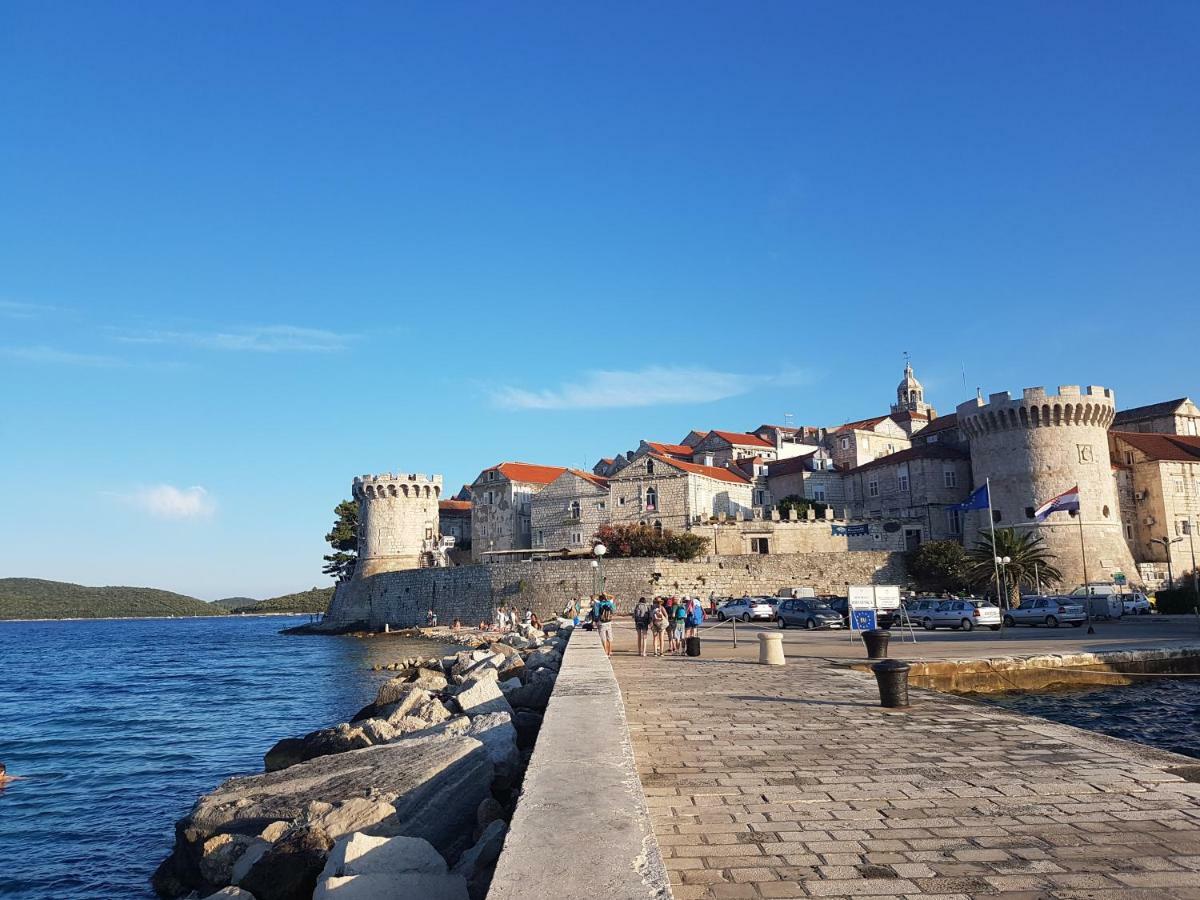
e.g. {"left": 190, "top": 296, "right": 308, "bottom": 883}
{"left": 842, "top": 444, "right": 973, "bottom": 550}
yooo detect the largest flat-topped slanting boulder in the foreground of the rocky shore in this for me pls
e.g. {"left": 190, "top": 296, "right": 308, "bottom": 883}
{"left": 154, "top": 734, "right": 498, "bottom": 896}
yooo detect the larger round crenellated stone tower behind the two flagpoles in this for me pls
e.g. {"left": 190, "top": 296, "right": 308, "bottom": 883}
{"left": 958, "top": 385, "right": 1138, "bottom": 590}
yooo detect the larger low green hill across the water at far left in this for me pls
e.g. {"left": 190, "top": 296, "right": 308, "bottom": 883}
{"left": 0, "top": 578, "right": 222, "bottom": 619}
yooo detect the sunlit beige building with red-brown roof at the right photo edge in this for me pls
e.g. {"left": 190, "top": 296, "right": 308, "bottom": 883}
{"left": 1109, "top": 434, "right": 1200, "bottom": 583}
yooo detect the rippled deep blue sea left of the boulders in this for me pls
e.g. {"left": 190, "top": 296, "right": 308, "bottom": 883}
{"left": 0, "top": 617, "right": 437, "bottom": 900}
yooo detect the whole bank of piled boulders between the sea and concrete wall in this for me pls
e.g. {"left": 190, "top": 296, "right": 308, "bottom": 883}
{"left": 151, "top": 624, "right": 570, "bottom": 900}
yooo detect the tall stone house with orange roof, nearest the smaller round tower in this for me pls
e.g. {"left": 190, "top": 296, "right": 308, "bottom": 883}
{"left": 470, "top": 462, "right": 566, "bottom": 562}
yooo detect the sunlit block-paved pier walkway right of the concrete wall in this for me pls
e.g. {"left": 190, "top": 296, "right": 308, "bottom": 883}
{"left": 613, "top": 622, "right": 1200, "bottom": 900}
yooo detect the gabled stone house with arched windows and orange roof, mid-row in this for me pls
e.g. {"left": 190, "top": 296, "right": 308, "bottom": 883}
{"left": 608, "top": 454, "right": 754, "bottom": 530}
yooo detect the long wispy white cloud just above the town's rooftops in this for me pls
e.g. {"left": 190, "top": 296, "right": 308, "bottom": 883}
{"left": 492, "top": 366, "right": 809, "bottom": 409}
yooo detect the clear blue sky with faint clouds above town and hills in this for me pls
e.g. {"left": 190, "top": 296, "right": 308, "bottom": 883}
{"left": 0, "top": 2, "right": 1200, "bottom": 599}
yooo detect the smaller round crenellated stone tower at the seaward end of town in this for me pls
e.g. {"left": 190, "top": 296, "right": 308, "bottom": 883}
{"left": 353, "top": 473, "right": 442, "bottom": 578}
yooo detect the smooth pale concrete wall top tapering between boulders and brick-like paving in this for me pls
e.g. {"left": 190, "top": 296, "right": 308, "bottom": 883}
{"left": 487, "top": 628, "right": 671, "bottom": 900}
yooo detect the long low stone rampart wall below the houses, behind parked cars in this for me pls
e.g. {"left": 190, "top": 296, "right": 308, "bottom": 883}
{"left": 325, "top": 551, "right": 905, "bottom": 629}
